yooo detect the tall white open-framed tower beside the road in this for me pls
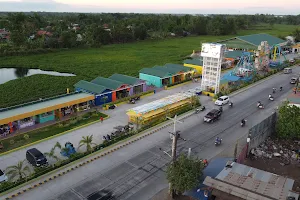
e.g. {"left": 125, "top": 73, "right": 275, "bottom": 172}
{"left": 201, "top": 43, "right": 226, "bottom": 94}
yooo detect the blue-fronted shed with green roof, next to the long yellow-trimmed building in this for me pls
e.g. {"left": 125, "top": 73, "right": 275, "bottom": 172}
{"left": 74, "top": 80, "right": 113, "bottom": 106}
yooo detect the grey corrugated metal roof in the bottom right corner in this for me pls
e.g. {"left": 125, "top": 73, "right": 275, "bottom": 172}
{"left": 204, "top": 162, "right": 294, "bottom": 200}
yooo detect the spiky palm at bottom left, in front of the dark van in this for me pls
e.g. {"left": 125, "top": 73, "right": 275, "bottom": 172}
{"left": 6, "top": 160, "right": 30, "bottom": 181}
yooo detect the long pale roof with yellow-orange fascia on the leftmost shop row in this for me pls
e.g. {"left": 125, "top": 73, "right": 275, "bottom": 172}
{"left": 0, "top": 93, "right": 95, "bottom": 124}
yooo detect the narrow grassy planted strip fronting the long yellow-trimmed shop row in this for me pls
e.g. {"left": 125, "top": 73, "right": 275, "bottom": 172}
{"left": 0, "top": 112, "right": 107, "bottom": 153}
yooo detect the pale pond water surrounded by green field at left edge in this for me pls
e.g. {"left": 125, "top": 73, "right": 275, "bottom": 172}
{"left": 0, "top": 68, "right": 76, "bottom": 84}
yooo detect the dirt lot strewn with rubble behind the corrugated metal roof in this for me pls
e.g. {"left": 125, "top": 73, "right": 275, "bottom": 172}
{"left": 244, "top": 138, "right": 300, "bottom": 192}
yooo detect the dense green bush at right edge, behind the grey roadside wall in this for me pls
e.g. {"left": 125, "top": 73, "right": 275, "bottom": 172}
{"left": 276, "top": 104, "right": 300, "bottom": 139}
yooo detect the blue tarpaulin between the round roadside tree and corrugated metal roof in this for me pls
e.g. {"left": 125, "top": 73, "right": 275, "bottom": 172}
{"left": 185, "top": 158, "right": 233, "bottom": 200}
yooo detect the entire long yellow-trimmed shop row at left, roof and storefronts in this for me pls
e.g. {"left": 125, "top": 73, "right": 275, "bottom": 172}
{"left": 0, "top": 93, "right": 95, "bottom": 134}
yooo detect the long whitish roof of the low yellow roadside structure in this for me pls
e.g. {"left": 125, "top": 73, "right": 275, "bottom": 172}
{"left": 128, "top": 92, "right": 194, "bottom": 114}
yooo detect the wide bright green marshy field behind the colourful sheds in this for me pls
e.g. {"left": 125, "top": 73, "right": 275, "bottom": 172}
{"left": 0, "top": 25, "right": 295, "bottom": 108}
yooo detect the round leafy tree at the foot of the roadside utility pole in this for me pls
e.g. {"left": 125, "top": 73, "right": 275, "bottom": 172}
{"left": 167, "top": 154, "right": 203, "bottom": 194}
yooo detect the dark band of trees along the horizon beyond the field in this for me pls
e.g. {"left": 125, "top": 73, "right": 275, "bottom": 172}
{"left": 0, "top": 13, "right": 300, "bottom": 49}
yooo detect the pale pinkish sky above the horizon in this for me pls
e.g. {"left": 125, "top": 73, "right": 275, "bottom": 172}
{"left": 0, "top": 0, "right": 300, "bottom": 15}
